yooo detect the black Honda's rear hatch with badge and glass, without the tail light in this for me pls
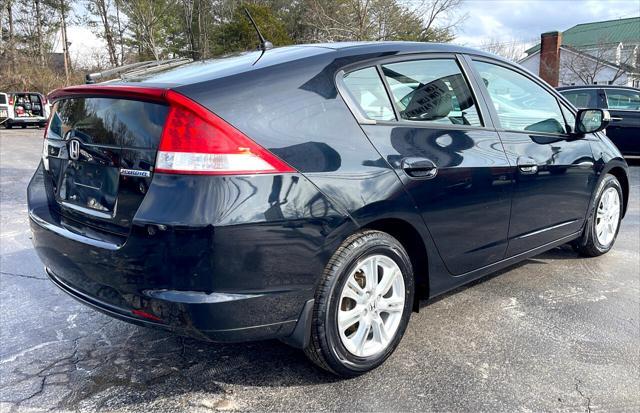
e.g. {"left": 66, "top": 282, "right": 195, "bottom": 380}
{"left": 43, "top": 88, "right": 169, "bottom": 238}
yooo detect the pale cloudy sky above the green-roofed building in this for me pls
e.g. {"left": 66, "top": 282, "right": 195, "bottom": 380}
{"left": 456, "top": 0, "right": 640, "bottom": 46}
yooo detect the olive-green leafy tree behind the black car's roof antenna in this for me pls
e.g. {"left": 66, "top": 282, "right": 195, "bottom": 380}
{"left": 213, "top": 3, "right": 293, "bottom": 54}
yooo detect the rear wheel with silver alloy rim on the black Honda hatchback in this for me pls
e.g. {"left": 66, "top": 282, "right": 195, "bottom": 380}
{"left": 305, "top": 231, "right": 414, "bottom": 377}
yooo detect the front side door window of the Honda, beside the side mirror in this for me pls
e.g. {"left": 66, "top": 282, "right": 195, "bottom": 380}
{"left": 474, "top": 62, "right": 567, "bottom": 133}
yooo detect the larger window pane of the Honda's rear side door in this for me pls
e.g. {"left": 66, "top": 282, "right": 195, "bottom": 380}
{"left": 382, "top": 59, "right": 482, "bottom": 126}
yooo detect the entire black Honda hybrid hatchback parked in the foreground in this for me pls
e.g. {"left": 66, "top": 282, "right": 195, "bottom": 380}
{"left": 28, "top": 42, "right": 629, "bottom": 376}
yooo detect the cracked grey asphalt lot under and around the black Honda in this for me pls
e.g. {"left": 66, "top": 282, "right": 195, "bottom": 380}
{"left": 0, "top": 129, "right": 640, "bottom": 412}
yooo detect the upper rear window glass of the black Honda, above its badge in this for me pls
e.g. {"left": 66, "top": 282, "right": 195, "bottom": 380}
{"left": 48, "top": 98, "right": 169, "bottom": 148}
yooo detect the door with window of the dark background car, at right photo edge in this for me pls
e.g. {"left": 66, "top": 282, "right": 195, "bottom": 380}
{"left": 604, "top": 88, "right": 640, "bottom": 156}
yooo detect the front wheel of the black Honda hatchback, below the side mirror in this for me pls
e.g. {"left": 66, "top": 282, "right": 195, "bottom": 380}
{"left": 573, "top": 174, "right": 623, "bottom": 257}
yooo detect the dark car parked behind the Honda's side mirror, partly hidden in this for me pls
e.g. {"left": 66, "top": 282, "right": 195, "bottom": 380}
{"left": 558, "top": 85, "right": 640, "bottom": 157}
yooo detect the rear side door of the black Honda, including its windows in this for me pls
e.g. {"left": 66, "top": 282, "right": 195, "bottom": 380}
{"left": 343, "top": 54, "right": 512, "bottom": 275}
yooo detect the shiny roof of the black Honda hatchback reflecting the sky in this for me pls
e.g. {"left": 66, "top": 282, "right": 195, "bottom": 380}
{"left": 117, "top": 41, "right": 504, "bottom": 86}
